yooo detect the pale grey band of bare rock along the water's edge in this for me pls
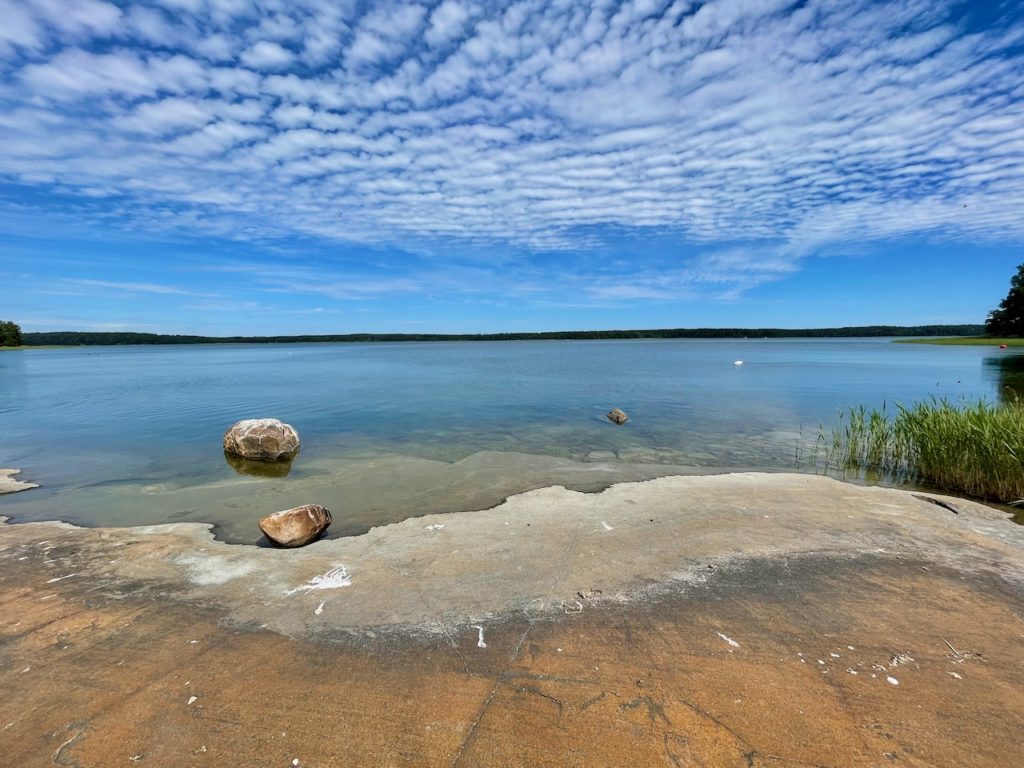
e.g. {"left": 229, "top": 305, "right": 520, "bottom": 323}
{"left": 0, "top": 473, "right": 1024, "bottom": 636}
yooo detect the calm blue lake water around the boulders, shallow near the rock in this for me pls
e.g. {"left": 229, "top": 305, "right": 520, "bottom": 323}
{"left": 0, "top": 339, "right": 1024, "bottom": 542}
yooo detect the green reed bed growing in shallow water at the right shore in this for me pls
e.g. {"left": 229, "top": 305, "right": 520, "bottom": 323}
{"left": 819, "top": 399, "right": 1024, "bottom": 504}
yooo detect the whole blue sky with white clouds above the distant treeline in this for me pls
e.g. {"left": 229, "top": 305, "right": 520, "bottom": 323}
{"left": 0, "top": 0, "right": 1024, "bottom": 335}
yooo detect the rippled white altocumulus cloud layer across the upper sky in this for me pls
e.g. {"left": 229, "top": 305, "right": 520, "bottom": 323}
{"left": 0, "top": 0, "right": 1024, "bottom": 298}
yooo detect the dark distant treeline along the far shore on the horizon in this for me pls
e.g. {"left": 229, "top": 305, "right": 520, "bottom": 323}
{"left": 8, "top": 325, "right": 984, "bottom": 349}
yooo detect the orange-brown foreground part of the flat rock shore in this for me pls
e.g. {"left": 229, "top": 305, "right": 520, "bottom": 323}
{"left": 0, "top": 557, "right": 1024, "bottom": 768}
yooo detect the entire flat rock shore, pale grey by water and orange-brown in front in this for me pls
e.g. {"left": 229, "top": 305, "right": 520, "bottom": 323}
{"left": 0, "top": 474, "right": 1024, "bottom": 768}
